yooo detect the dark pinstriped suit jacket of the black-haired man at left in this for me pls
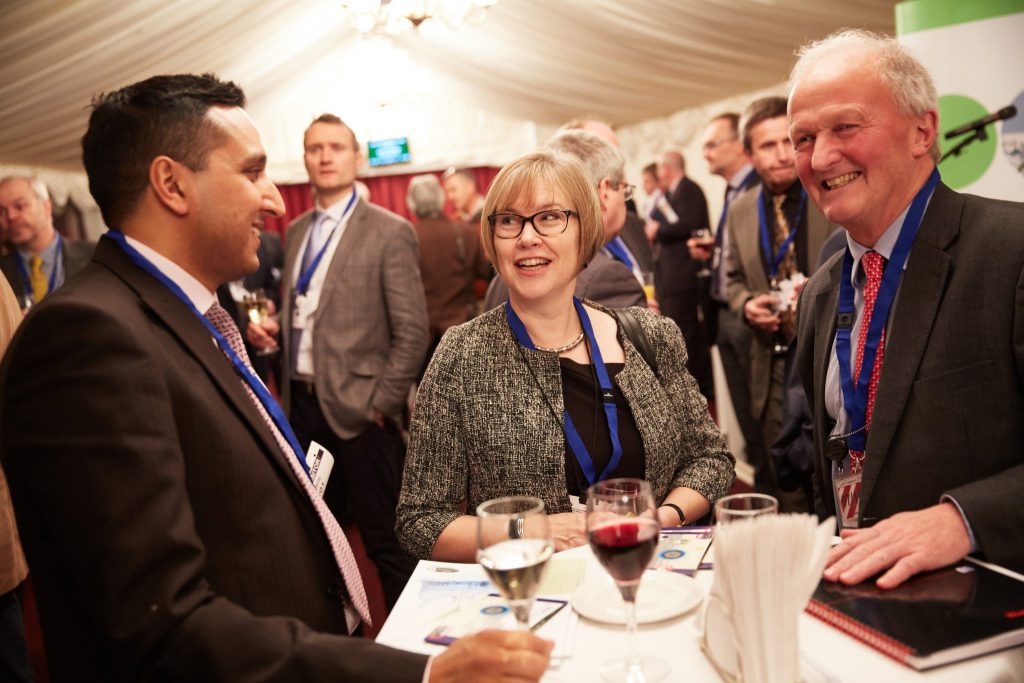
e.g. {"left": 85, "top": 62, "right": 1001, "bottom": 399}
{"left": 0, "top": 253, "right": 425, "bottom": 682}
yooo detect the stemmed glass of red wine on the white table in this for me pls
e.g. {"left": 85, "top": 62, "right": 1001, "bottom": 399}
{"left": 587, "top": 479, "right": 669, "bottom": 683}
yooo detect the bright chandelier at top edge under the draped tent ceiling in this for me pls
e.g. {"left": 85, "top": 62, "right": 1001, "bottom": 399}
{"left": 341, "top": 0, "right": 498, "bottom": 36}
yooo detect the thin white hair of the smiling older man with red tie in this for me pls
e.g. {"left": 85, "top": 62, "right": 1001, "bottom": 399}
{"left": 786, "top": 29, "right": 942, "bottom": 163}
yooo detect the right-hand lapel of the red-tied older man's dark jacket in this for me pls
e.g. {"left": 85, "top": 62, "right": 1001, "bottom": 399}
{"left": 860, "top": 183, "right": 964, "bottom": 510}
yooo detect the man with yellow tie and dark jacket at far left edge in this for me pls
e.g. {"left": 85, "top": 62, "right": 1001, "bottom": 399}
{"left": 0, "top": 176, "right": 94, "bottom": 308}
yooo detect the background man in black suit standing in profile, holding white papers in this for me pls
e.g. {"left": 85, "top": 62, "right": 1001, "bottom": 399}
{"left": 645, "top": 152, "right": 715, "bottom": 397}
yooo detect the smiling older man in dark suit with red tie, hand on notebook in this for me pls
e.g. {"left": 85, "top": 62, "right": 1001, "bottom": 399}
{"left": 790, "top": 31, "right": 1024, "bottom": 588}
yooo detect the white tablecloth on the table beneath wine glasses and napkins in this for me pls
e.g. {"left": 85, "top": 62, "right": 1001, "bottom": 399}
{"left": 377, "top": 546, "right": 1024, "bottom": 683}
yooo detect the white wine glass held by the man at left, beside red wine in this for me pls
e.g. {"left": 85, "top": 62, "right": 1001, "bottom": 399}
{"left": 476, "top": 496, "right": 555, "bottom": 631}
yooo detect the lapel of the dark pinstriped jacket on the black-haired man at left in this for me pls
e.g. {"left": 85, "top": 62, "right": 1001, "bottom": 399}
{"left": 94, "top": 240, "right": 301, "bottom": 497}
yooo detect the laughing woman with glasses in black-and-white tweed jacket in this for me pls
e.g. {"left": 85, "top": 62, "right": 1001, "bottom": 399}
{"left": 397, "top": 150, "right": 734, "bottom": 562}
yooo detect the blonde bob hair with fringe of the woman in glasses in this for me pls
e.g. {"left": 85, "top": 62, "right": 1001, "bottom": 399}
{"left": 480, "top": 150, "right": 604, "bottom": 272}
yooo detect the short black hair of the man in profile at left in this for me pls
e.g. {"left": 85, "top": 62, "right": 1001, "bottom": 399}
{"left": 82, "top": 74, "right": 246, "bottom": 227}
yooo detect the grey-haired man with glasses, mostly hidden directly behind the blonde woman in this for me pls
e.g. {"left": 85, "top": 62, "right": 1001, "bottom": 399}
{"left": 483, "top": 129, "right": 647, "bottom": 310}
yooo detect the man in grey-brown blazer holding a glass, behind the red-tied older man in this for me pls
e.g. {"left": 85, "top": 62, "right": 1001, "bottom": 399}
{"left": 725, "top": 97, "right": 834, "bottom": 511}
